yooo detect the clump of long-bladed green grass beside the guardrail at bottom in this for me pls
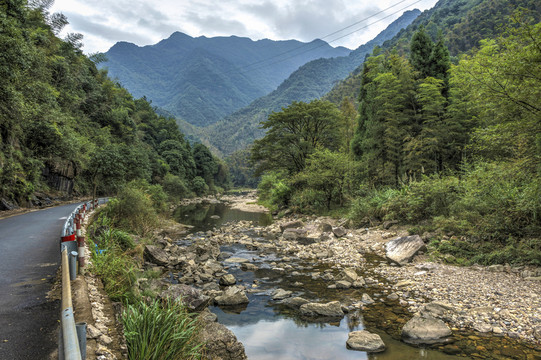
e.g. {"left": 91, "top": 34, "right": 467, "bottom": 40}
{"left": 122, "top": 300, "right": 202, "bottom": 360}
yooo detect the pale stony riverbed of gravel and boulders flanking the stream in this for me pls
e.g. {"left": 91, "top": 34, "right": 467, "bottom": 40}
{"left": 138, "top": 194, "right": 541, "bottom": 359}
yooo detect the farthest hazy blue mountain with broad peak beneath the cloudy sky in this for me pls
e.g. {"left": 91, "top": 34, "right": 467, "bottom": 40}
{"left": 101, "top": 32, "right": 351, "bottom": 126}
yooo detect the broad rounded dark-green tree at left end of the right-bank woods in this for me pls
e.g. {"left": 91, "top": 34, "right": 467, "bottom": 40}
{"left": 251, "top": 100, "right": 341, "bottom": 176}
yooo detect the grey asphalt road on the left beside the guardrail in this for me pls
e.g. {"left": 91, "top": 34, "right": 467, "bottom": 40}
{"left": 0, "top": 204, "right": 82, "bottom": 360}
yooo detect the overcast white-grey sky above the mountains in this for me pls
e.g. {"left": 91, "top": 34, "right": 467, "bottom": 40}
{"left": 50, "top": 0, "right": 436, "bottom": 54}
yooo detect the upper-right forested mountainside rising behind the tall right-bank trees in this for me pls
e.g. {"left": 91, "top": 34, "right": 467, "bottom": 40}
{"left": 325, "top": 0, "right": 541, "bottom": 105}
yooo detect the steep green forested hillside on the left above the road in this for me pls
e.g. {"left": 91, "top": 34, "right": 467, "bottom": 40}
{"left": 0, "top": 0, "right": 227, "bottom": 208}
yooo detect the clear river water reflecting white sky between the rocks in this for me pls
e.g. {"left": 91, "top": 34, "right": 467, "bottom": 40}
{"left": 174, "top": 204, "right": 535, "bottom": 360}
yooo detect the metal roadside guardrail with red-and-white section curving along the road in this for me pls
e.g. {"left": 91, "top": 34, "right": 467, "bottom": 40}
{"left": 58, "top": 198, "right": 108, "bottom": 360}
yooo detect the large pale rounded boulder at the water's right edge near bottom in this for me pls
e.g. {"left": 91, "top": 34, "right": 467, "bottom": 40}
{"left": 402, "top": 315, "right": 451, "bottom": 344}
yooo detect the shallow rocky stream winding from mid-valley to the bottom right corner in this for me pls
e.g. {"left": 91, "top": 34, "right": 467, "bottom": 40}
{"left": 168, "top": 203, "right": 539, "bottom": 359}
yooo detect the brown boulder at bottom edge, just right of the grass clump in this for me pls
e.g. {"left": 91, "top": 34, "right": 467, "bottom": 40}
{"left": 199, "top": 322, "right": 247, "bottom": 360}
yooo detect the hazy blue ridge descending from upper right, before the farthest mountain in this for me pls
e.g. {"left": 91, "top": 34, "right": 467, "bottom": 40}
{"left": 194, "top": 9, "right": 421, "bottom": 155}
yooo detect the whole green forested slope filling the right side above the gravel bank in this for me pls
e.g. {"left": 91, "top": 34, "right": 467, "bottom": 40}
{"left": 251, "top": 0, "right": 541, "bottom": 265}
